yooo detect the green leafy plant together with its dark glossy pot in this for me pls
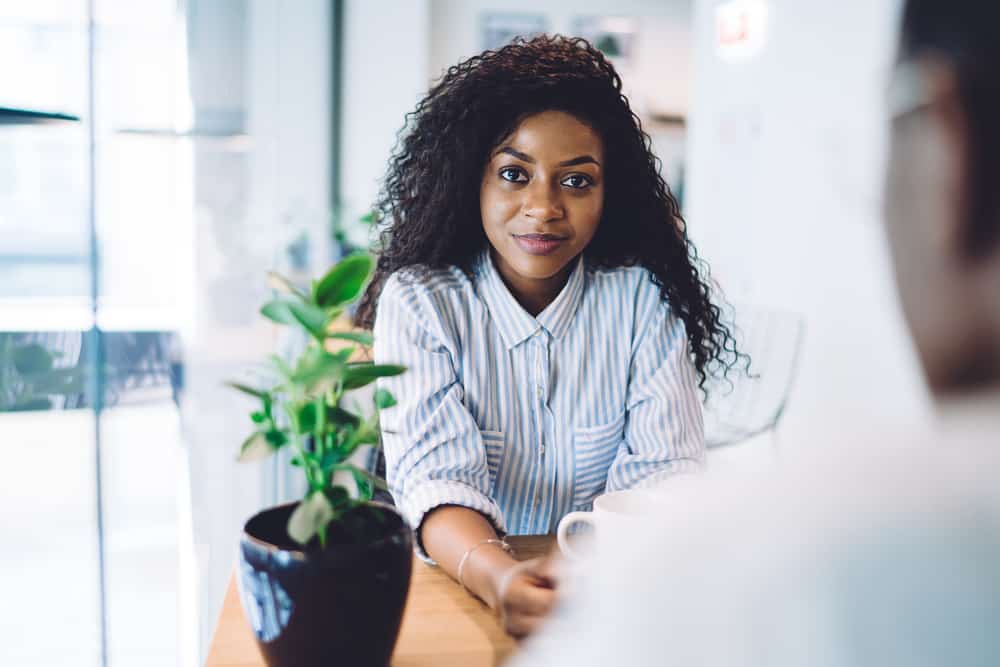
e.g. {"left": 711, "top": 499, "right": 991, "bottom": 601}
{"left": 231, "top": 254, "right": 412, "bottom": 667}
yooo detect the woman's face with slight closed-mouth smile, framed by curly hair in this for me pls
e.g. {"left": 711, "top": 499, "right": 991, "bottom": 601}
{"left": 479, "top": 111, "right": 604, "bottom": 290}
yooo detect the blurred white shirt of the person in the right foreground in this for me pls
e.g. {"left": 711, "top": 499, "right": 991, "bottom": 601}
{"left": 510, "top": 422, "right": 1000, "bottom": 667}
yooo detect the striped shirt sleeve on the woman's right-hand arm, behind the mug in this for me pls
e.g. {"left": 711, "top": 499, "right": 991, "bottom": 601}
{"left": 607, "top": 286, "right": 705, "bottom": 491}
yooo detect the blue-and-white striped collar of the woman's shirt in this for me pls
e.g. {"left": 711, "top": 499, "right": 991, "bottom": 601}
{"left": 476, "top": 248, "right": 585, "bottom": 349}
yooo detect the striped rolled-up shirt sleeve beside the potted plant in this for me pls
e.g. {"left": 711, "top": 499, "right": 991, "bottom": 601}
{"left": 374, "top": 275, "right": 505, "bottom": 559}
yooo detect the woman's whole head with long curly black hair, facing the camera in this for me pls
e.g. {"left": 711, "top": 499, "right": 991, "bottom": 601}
{"left": 356, "top": 36, "right": 736, "bottom": 392}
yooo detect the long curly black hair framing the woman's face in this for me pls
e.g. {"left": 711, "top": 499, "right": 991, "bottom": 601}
{"left": 355, "top": 35, "right": 742, "bottom": 390}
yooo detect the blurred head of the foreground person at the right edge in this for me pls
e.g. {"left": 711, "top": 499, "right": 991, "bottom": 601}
{"left": 886, "top": 0, "right": 1000, "bottom": 393}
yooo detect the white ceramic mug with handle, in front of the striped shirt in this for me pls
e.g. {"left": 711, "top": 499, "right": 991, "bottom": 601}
{"left": 556, "top": 489, "right": 667, "bottom": 560}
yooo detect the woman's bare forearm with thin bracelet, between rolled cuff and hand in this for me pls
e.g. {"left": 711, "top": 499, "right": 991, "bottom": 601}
{"left": 420, "top": 505, "right": 517, "bottom": 609}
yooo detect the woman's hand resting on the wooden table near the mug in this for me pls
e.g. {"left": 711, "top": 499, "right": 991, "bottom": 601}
{"left": 495, "top": 557, "right": 557, "bottom": 638}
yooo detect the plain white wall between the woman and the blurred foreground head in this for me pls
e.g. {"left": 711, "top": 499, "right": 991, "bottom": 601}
{"left": 687, "top": 0, "right": 927, "bottom": 443}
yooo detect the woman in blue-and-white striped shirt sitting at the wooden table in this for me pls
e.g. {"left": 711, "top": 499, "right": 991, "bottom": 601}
{"left": 358, "top": 37, "right": 736, "bottom": 635}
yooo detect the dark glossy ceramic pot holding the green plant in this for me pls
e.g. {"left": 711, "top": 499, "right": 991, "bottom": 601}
{"left": 239, "top": 503, "right": 413, "bottom": 667}
